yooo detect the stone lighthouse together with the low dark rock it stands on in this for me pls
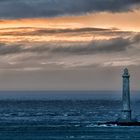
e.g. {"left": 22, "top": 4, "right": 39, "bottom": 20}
{"left": 98, "top": 68, "right": 140, "bottom": 126}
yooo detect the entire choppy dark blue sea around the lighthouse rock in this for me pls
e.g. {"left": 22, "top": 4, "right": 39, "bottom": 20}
{"left": 0, "top": 91, "right": 140, "bottom": 140}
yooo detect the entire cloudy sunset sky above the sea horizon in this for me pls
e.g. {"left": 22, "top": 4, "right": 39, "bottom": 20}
{"left": 0, "top": 0, "right": 140, "bottom": 90}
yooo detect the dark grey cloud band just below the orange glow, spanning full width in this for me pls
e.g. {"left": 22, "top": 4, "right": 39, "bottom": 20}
{"left": 0, "top": 34, "right": 140, "bottom": 55}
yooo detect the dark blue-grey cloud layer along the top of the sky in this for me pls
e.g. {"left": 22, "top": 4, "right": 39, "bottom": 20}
{"left": 0, "top": 0, "right": 140, "bottom": 18}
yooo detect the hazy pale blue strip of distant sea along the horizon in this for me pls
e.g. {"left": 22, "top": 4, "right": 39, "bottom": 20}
{"left": 0, "top": 91, "right": 140, "bottom": 101}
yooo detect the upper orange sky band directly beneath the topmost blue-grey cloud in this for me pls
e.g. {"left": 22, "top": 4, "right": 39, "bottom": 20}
{"left": 0, "top": 10, "right": 140, "bottom": 32}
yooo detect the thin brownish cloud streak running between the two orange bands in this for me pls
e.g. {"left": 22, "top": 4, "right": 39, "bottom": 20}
{"left": 0, "top": 27, "right": 134, "bottom": 36}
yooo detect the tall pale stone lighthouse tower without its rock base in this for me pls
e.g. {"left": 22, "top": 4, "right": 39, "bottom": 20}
{"left": 121, "top": 68, "right": 132, "bottom": 122}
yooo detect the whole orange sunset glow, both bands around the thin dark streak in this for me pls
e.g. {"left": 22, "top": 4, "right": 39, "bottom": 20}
{"left": 0, "top": 10, "right": 140, "bottom": 43}
